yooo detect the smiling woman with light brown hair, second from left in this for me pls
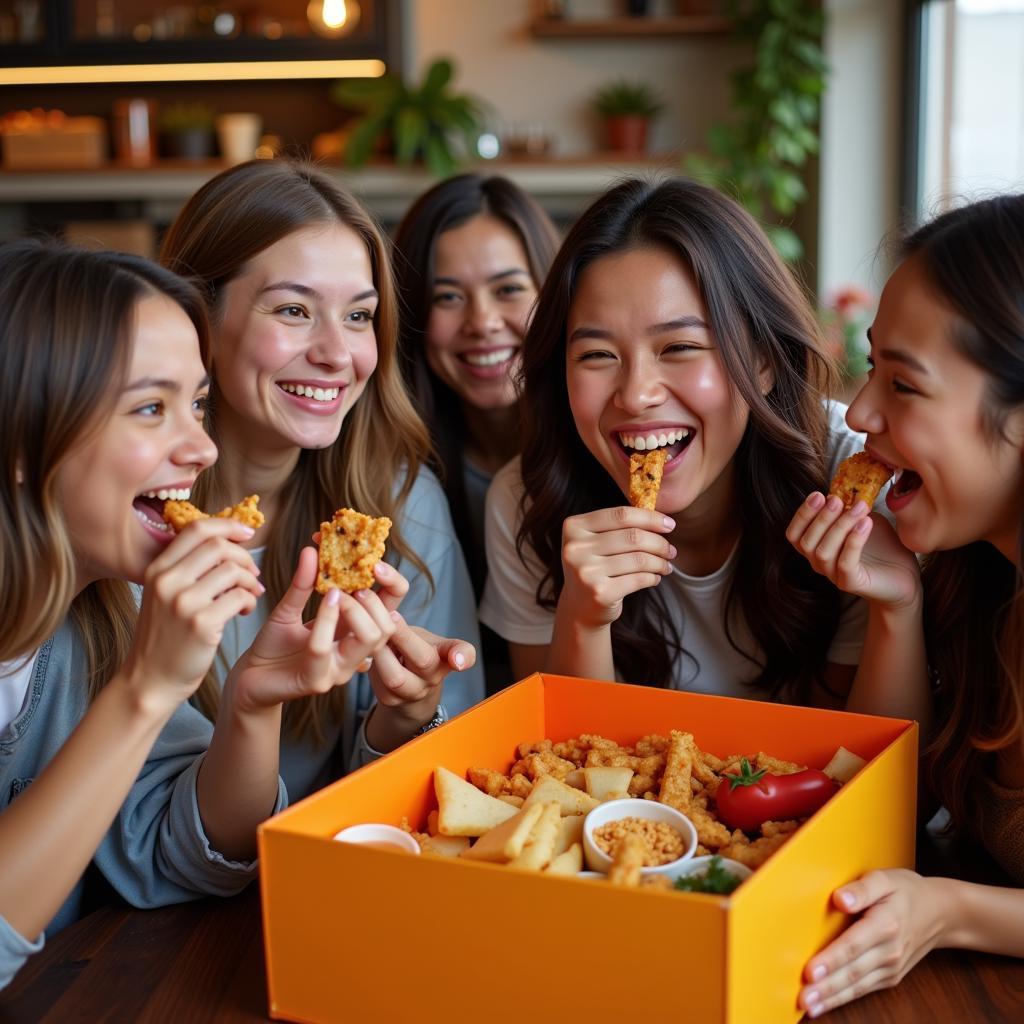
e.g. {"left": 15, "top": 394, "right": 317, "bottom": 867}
{"left": 161, "top": 161, "right": 483, "bottom": 799}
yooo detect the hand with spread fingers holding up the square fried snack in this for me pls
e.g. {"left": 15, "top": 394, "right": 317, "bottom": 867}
{"left": 228, "top": 548, "right": 409, "bottom": 712}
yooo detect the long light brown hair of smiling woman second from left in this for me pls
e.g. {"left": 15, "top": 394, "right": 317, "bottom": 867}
{"left": 160, "top": 160, "right": 430, "bottom": 740}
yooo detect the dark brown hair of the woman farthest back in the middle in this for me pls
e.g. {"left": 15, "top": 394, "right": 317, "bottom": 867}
{"left": 395, "top": 174, "right": 558, "bottom": 595}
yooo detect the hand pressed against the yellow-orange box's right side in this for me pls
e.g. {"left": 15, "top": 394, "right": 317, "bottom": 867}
{"left": 799, "top": 869, "right": 946, "bottom": 1017}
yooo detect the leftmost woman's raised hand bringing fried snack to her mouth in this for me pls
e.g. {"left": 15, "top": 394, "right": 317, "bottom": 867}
{"left": 125, "top": 518, "right": 264, "bottom": 707}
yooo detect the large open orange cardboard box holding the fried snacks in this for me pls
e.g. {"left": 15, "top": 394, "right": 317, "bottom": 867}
{"left": 259, "top": 675, "right": 918, "bottom": 1024}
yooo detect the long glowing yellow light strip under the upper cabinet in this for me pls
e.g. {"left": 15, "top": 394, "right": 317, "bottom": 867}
{"left": 0, "top": 60, "right": 387, "bottom": 85}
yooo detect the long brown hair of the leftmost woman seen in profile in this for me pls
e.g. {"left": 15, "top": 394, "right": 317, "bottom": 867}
{"left": 0, "top": 241, "right": 209, "bottom": 698}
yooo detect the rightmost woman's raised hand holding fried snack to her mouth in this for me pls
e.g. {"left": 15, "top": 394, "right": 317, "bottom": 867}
{"left": 785, "top": 492, "right": 922, "bottom": 610}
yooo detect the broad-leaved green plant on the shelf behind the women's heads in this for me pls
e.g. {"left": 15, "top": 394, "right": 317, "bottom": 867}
{"left": 331, "top": 59, "right": 483, "bottom": 177}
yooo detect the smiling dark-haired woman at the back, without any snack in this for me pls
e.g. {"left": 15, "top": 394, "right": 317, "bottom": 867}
{"left": 395, "top": 174, "right": 558, "bottom": 691}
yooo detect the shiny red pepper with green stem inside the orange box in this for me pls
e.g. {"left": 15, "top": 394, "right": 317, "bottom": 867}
{"left": 716, "top": 758, "right": 838, "bottom": 833}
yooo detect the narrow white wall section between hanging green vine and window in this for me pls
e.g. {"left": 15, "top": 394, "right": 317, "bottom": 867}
{"left": 818, "top": 0, "right": 903, "bottom": 298}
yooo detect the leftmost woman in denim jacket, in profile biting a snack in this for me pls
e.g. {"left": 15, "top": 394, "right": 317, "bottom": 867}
{"left": 0, "top": 242, "right": 284, "bottom": 987}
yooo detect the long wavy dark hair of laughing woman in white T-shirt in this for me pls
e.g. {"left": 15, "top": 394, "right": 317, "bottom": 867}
{"left": 518, "top": 179, "right": 840, "bottom": 700}
